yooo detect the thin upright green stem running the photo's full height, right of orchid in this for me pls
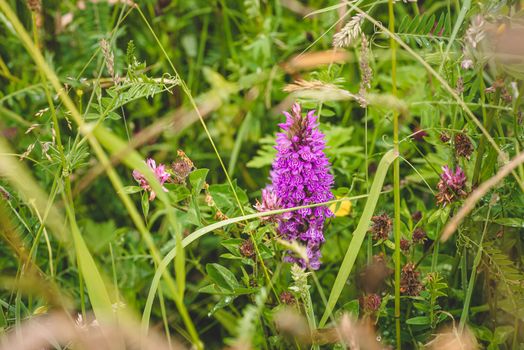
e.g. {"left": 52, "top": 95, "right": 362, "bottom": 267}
{"left": 388, "top": 0, "right": 402, "bottom": 349}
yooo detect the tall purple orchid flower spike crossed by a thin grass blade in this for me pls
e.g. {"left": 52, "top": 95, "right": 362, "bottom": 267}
{"left": 264, "top": 103, "right": 333, "bottom": 270}
